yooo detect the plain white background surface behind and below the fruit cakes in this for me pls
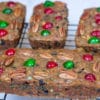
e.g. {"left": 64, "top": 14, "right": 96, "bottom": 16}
{"left": 0, "top": 0, "right": 100, "bottom": 100}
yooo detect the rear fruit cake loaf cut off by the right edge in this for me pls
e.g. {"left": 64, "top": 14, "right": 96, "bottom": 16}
{"left": 76, "top": 8, "right": 100, "bottom": 51}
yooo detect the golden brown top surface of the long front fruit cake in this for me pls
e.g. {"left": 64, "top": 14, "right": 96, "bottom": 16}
{"left": 0, "top": 48, "right": 100, "bottom": 88}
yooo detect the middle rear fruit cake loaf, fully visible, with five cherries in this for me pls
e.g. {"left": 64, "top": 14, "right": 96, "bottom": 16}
{"left": 28, "top": 1, "right": 68, "bottom": 49}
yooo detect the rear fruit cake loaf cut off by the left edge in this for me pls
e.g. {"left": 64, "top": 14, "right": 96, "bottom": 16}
{"left": 0, "top": 1, "right": 25, "bottom": 50}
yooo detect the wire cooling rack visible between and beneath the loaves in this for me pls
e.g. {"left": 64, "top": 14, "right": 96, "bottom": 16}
{"left": 0, "top": 23, "right": 100, "bottom": 100}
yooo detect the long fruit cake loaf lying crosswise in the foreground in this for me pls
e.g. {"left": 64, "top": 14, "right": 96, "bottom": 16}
{"left": 0, "top": 48, "right": 100, "bottom": 100}
